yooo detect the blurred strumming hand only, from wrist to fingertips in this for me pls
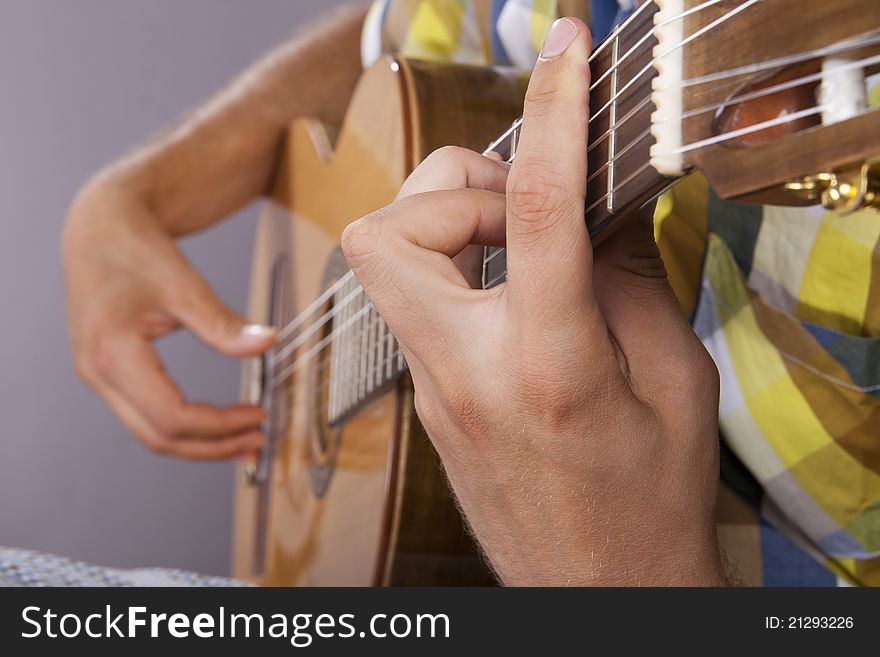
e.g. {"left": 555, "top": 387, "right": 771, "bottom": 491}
{"left": 64, "top": 187, "right": 274, "bottom": 459}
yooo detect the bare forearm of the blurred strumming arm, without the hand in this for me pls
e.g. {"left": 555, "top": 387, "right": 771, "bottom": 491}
{"left": 73, "top": 7, "right": 365, "bottom": 236}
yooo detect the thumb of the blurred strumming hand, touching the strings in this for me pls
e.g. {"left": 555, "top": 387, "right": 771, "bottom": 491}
{"left": 172, "top": 279, "right": 277, "bottom": 358}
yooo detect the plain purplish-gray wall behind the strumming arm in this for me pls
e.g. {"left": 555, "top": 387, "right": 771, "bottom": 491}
{"left": 0, "top": 0, "right": 350, "bottom": 574}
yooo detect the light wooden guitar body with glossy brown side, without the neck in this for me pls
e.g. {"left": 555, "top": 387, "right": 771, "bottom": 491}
{"left": 234, "top": 58, "right": 524, "bottom": 586}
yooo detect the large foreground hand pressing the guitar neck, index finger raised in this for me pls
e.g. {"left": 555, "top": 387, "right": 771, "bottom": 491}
{"left": 343, "top": 19, "right": 723, "bottom": 585}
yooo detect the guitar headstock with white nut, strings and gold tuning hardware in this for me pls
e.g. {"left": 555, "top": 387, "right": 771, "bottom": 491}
{"left": 651, "top": 0, "right": 880, "bottom": 211}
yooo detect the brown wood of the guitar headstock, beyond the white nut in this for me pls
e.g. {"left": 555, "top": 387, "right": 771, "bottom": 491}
{"left": 684, "top": 0, "right": 880, "bottom": 204}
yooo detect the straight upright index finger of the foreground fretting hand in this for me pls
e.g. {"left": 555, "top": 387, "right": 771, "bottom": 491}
{"left": 507, "top": 18, "right": 595, "bottom": 320}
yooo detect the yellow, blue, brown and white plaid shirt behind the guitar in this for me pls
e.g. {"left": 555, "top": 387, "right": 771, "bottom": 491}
{"left": 372, "top": 0, "right": 880, "bottom": 586}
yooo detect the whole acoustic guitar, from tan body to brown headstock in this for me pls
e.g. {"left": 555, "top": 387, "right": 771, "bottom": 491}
{"left": 234, "top": 0, "right": 880, "bottom": 586}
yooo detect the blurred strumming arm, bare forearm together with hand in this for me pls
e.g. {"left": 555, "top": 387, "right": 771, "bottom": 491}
{"left": 62, "top": 6, "right": 366, "bottom": 459}
